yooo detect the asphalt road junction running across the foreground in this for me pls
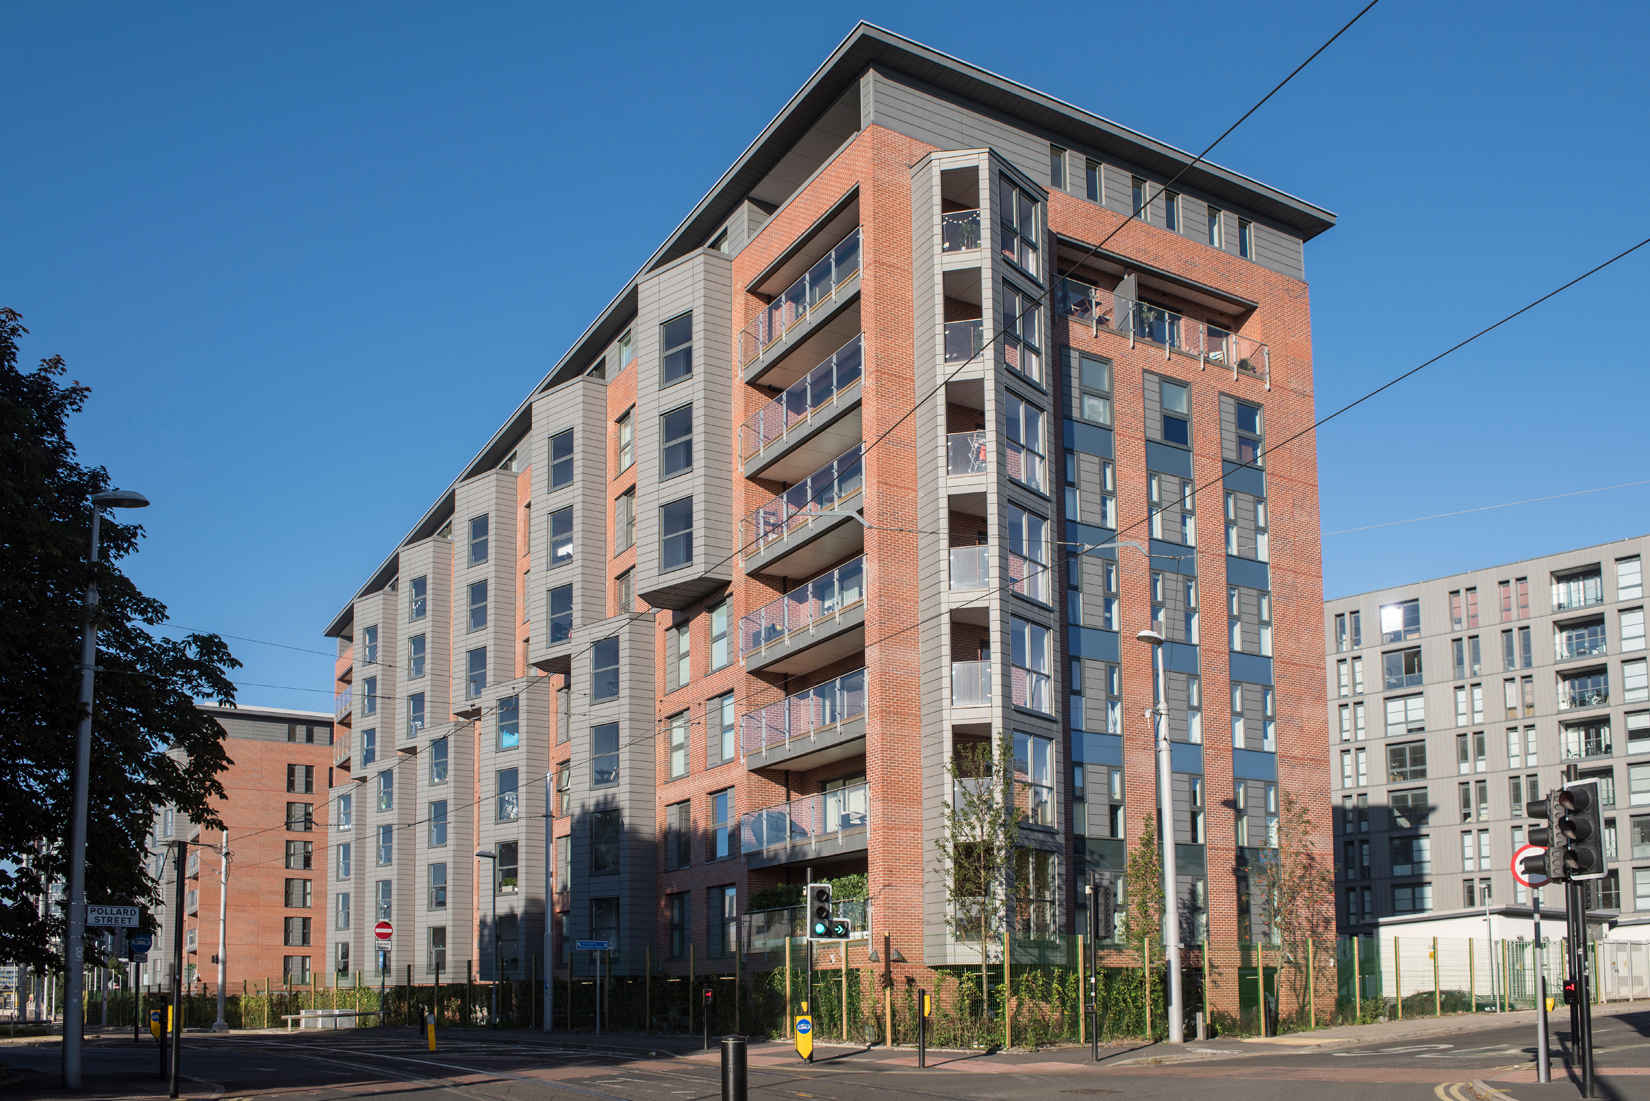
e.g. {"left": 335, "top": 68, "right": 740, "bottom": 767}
{"left": 0, "top": 1012, "right": 1650, "bottom": 1101}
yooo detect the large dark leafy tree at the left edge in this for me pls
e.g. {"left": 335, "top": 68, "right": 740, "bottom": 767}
{"left": 0, "top": 309, "right": 239, "bottom": 969}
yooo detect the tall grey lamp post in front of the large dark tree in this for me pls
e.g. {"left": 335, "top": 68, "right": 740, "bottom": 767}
{"left": 63, "top": 489, "right": 149, "bottom": 1089}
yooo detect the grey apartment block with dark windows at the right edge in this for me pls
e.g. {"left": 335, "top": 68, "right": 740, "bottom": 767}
{"left": 1323, "top": 536, "right": 1650, "bottom": 933}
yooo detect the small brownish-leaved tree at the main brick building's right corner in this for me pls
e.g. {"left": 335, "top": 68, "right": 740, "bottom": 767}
{"left": 1251, "top": 792, "right": 1335, "bottom": 1012}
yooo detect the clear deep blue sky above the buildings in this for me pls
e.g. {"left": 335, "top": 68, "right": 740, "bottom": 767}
{"left": 0, "top": 0, "right": 1650, "bottom": 710}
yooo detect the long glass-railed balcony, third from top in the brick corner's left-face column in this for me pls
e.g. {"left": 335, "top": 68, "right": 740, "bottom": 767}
{"left": 739, "top": 444, "right": 865, "bottom": 576}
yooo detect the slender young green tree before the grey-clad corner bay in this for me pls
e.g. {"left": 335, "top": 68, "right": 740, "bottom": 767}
{"left": 934, "top": 735, "right": 1018, "bottom": 1016}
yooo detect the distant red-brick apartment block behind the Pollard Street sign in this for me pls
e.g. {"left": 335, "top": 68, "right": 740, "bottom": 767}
{"left": 139, "top": 705, "right": 332, "bottom": 990}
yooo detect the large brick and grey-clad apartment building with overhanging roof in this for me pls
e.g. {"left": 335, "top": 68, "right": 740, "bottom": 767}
{"left": 327, "top": 25, "right": 1333, "bottom": 976}
